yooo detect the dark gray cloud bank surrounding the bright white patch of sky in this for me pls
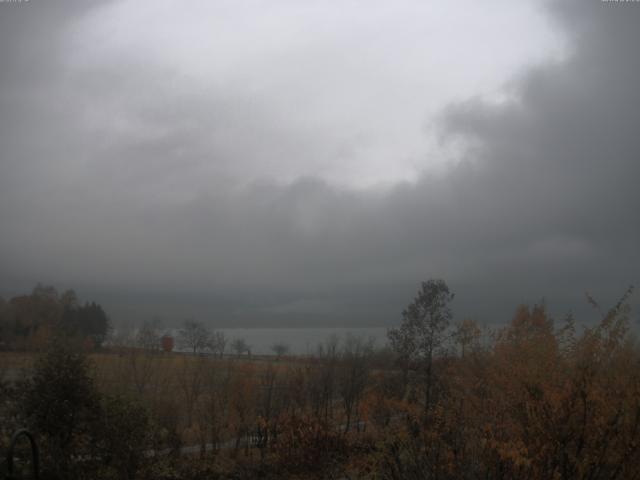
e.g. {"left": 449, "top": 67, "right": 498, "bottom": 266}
{"left": 0, "top": 1, "right": 640, "bottom": 325}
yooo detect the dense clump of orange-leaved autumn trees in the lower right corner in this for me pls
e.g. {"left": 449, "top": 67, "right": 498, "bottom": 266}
{"left": 378, "top": 289, "right": 640, "bottom": 480}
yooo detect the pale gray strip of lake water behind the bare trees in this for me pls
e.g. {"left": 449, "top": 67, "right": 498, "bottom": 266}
{"left": 217, "top": 327, "right": 387, "bottom": 355}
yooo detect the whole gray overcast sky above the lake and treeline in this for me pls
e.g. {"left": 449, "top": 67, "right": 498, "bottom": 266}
{"left": 0, "top": 0, "right": 640, "bottom": 326}
